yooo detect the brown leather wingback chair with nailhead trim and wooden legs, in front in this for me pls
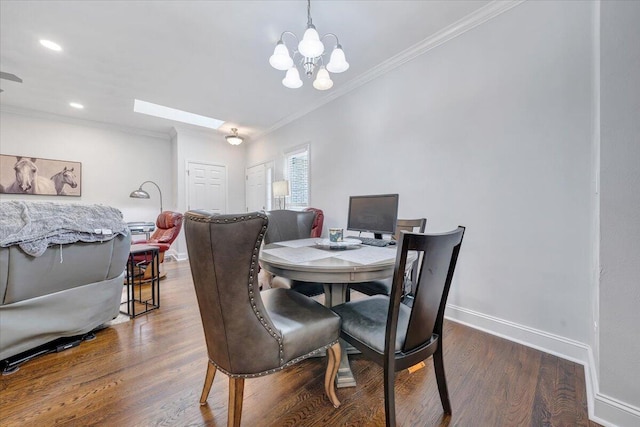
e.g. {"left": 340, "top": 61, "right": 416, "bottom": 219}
{"left": 185, "top": 211, "right": 340, "bottom": 426}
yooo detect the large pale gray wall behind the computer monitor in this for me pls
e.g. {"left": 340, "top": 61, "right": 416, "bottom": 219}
{"left": 247, "top": 2, "right": 594, "bottom": 343}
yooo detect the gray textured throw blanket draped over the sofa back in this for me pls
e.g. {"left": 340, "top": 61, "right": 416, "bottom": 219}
{"left": 0, "top": 200, "right": 129, "bottom": 257}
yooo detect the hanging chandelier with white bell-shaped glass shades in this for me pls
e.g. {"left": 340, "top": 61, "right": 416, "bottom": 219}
{"left": 269, "top": 0, "right": 349, "bottom": 90}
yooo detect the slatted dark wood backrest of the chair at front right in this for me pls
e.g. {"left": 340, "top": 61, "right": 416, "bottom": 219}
{"left": 385, "top": 227, "right": 465, "bottom": 355}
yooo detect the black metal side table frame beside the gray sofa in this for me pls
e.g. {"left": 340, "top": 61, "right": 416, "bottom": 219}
{"left": 120, "top": 245, "right": 160, "bottom": 318}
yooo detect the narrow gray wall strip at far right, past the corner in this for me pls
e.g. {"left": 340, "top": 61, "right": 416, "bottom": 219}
{"left": 599, "top": 1, "right": 640, "bottom": 414}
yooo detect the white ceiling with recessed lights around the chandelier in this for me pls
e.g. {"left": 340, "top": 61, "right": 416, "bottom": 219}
{"left": 0, "top": 0, "right": 489, "bottom": 137}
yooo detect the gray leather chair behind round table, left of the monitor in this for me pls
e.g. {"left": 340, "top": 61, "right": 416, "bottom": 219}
{"left": 264, "top": 209, "right": 324, "bottom": 297}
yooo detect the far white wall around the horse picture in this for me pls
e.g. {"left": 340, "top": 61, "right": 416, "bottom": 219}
{"left": 0, "top": 111, "right": 175, "bottom": 222}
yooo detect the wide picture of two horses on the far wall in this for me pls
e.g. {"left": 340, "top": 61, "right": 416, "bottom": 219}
{"left": 0, "top": 154, "right": 82, "bottom": 197}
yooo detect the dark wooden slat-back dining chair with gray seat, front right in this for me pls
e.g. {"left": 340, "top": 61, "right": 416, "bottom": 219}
{"left": 333, "top": 227, "right": 465, "bottom": 427}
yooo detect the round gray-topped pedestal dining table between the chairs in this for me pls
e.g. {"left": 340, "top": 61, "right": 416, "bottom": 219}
{"left": 260, "top": 238, "right": 415, "bottom": 388}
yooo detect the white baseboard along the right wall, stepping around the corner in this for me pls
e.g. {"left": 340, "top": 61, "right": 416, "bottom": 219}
{"left": 445, "top": 304, "right": 640, "bottom": 427}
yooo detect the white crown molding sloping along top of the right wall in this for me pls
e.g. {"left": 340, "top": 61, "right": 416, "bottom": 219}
{"left": 253, "top": 0, "right": 526, "bottom": 140}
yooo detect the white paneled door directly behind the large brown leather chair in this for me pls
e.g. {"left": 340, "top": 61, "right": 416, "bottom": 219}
{"left": 187, "top": 162, "right": 227, "bottom": 214}
